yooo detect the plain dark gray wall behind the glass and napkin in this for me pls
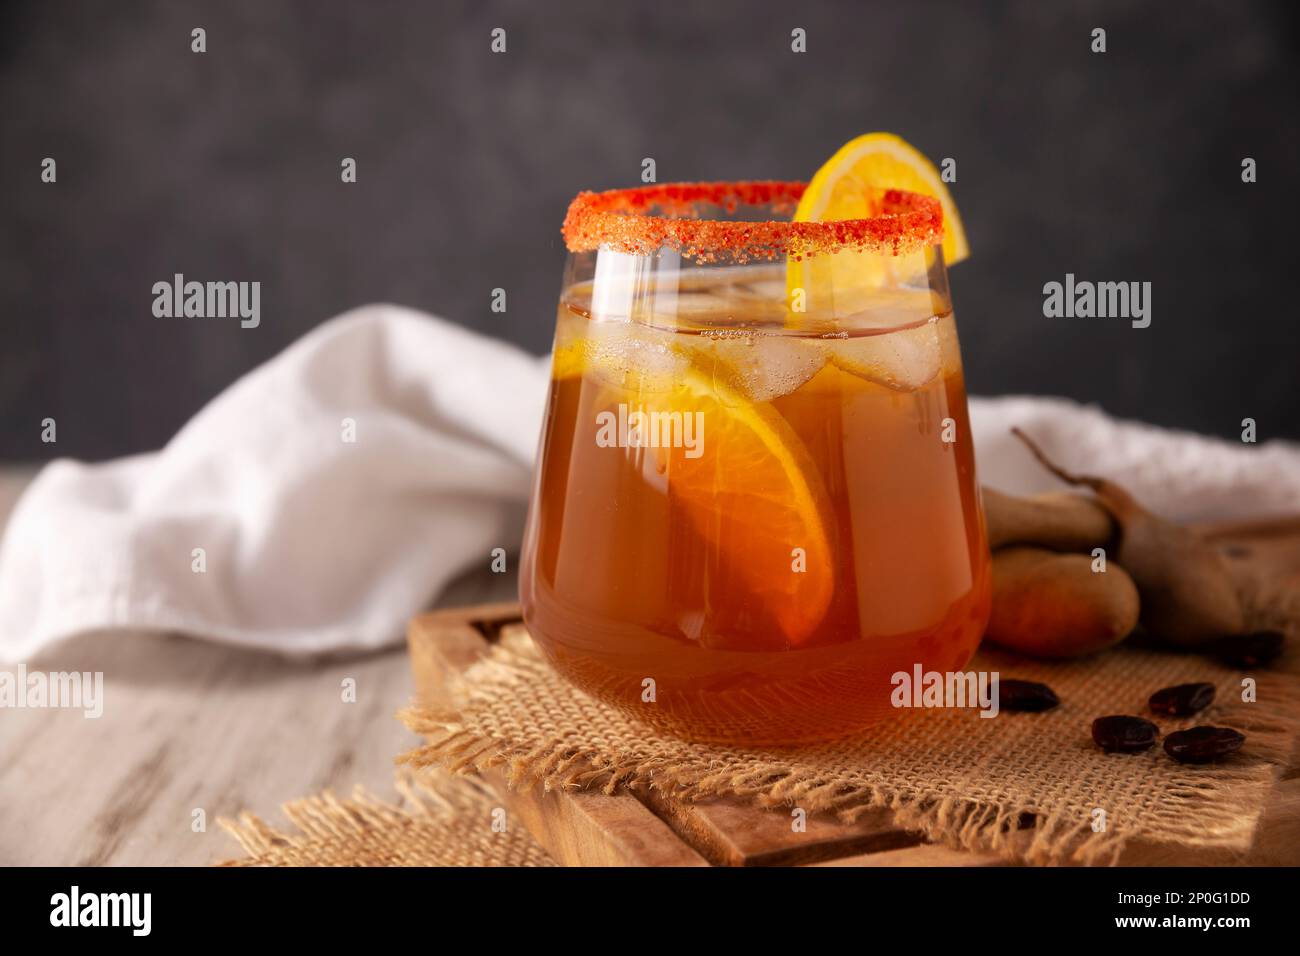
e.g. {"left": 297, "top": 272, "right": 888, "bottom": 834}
{"left": 0, "top": 0, "right": 1300, "bottom": 459}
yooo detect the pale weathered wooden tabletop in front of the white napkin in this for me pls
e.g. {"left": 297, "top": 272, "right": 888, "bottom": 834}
{"left": 0, "top": 468, "right": 515, "bottom": 866}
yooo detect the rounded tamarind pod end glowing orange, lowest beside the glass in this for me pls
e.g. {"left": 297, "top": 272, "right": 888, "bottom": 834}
{"left": 984, "top": 546, "right": 1140, "bottom": 658}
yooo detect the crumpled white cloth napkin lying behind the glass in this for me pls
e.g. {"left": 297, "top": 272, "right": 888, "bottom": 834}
{"left": 0, "top": 306, "right": 1300, "bottom": 661}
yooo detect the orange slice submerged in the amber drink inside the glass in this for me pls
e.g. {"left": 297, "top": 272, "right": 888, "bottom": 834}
{"left": 553, "top": 306, "right": 835, "bottom": 649}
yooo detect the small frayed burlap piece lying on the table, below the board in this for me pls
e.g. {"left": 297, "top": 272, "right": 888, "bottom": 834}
{"left": 217, "top": 770, "right": 554, "bottom": 866}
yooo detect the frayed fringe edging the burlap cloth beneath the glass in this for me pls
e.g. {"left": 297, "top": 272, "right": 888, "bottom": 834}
{"left": 398, "top": 574, "right": 1300, "bottom": 866}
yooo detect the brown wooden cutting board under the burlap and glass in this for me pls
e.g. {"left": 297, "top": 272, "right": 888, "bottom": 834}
{"left": 407, "top": 518, "right": 1300, "bottom": 866}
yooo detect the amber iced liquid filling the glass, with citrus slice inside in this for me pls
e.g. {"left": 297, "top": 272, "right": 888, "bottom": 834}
{"left": 520, "top": 280, "right": 989, "bottom": 745}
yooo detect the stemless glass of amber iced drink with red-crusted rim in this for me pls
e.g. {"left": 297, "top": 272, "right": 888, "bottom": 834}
{"left": 520, "top": 182, "right": 991, "bottom": 745}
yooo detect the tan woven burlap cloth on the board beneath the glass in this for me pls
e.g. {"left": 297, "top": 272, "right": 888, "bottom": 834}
{"left": 402, "top": 574, "right": 1300, "bottom": 864}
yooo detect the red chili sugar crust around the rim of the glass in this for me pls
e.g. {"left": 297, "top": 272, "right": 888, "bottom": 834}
{"left": 563, "top": 181, "right": 944, "bottom": 263}
